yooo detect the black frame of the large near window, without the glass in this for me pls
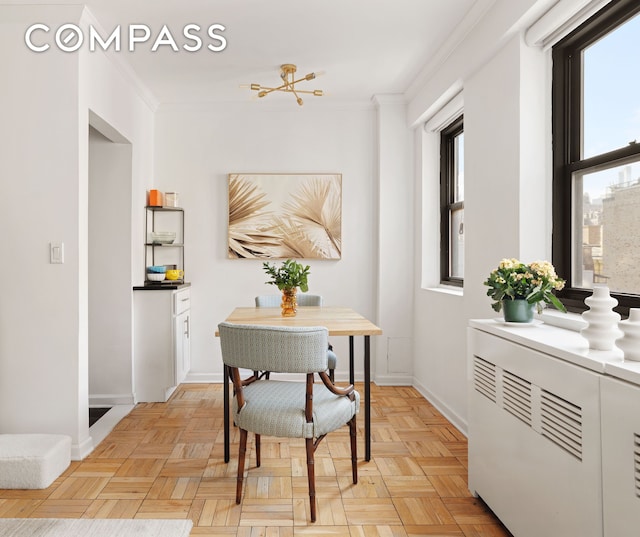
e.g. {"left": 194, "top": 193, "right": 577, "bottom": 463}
{"left": 551, "top": 0, "right": 640, "bottom": 315}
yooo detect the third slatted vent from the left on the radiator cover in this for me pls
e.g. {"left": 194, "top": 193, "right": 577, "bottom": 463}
{"left": 540, "top": 389, "right": 582, "bottom": 460}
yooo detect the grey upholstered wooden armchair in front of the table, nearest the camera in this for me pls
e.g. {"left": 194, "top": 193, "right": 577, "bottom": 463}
{"left": 218, "top": 323, "right": 360, "bottom": 522}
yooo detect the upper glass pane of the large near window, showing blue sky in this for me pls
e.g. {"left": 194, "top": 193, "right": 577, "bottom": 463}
{"left": 582, "top": 15, "right": 640, "bottom": 159}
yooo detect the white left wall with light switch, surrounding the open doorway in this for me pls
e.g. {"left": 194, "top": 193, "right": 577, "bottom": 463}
{"left": 0, "top": 5, "right": 153, "bottom": 458}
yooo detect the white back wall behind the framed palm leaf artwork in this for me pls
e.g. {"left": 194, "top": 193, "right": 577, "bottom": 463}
{"left": 154, "top": 100, "right": 384, "bottom": 381}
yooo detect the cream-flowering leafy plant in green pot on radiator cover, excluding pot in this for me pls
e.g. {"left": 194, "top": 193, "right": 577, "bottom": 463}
{"left": 484, "top": 259, "right": 567, "bottom": 313}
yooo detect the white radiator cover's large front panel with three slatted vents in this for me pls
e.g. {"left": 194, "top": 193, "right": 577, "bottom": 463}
{"left": 468, "top": 328, "right": 603, "bottom": 537}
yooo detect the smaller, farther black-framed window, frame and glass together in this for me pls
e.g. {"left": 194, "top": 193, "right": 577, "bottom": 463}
{"left": 440, "top": 116, "right": 464, "bottom": 287}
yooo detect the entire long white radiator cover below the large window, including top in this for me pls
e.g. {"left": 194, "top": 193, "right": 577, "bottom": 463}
{"left": 468, "top": 320, "right": 640, "bottom": 537}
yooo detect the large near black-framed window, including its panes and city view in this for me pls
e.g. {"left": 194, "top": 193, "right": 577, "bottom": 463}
{"left": 552, "top": 0, "right": 640, "bottom": 313}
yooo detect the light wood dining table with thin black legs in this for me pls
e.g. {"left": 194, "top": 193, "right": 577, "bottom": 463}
{"left": 216, "top": 306, "right": 382, "bottom": 462}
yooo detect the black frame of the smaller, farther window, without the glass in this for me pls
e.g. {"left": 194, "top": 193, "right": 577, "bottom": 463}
{"left": 440, "top": 114, "right": 464, "bottom": 287}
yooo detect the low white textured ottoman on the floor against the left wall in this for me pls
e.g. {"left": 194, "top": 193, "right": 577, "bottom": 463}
{"left": 0, "top": 434, "right": 71, "bottom": 489}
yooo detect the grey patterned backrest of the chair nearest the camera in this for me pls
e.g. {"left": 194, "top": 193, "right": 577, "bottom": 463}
{"left": 218, "top": 323, "right": 329, "bottom": 373}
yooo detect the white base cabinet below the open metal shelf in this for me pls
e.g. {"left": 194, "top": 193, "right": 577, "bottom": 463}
{"left": 133, "top": 286, "right": 191, "bottom": 403}
